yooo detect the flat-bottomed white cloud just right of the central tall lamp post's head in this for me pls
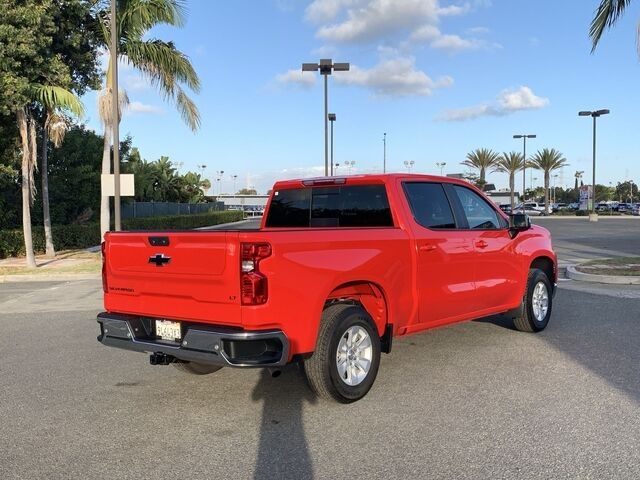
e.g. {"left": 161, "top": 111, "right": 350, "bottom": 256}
{"left": 336, "top": 57, "right": 453, "bottom": 96}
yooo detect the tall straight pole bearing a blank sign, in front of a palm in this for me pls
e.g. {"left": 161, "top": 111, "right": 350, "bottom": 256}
{"left": 111, "top": 0, "right": 122, "bottom": 232}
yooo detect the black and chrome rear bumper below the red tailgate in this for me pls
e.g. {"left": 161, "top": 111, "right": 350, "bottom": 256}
{"left": 97, "top": 313, "right": 289, "bottom": 367}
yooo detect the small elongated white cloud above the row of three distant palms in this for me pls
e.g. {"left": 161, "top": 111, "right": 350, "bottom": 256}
{"left": 437, "top": 86, "right": 549, "bottom": 122}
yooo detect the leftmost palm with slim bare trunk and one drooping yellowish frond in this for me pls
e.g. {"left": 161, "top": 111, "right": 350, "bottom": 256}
{"left": 16, "top": 84, "right": 84, "bottom": 268}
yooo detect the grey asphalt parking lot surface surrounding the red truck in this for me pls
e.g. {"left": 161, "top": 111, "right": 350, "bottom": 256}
{"left": 0, "top": 219, "right": 640, "bottom": 479}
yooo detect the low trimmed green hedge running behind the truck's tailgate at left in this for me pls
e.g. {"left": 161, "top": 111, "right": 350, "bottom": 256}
{"left": 0, "top": 211, "right": 242, "bottom": 258}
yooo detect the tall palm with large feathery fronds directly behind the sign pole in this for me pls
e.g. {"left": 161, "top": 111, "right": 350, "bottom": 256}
{"left": 99, "top": 0, "right": 200, "bottom": 235}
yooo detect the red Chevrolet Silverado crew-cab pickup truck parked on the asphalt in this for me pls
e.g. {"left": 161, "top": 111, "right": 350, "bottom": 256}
{"left": 98, "top": 174, "right": 557, "bottom": 403}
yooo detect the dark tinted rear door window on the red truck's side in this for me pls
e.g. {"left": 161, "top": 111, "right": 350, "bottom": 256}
{"left": 404, "top": 182, "right": 456, "bottom": 228}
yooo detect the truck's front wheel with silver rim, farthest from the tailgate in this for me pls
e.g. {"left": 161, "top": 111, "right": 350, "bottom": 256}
{"left": 513, "top": 268, "right": 553, "bottom": 332}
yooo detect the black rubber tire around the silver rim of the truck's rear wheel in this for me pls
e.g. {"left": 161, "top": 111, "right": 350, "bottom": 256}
{"left": 304, "top": 304, "right": 380, "bottom": 403}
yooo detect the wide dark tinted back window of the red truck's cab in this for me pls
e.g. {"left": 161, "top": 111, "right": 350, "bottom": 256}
{"left": 266, "top": 185, "right": 393, "bottom": 228}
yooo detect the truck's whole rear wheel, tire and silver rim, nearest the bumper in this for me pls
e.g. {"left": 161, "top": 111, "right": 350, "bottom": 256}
{"left": 304, "top": 304, "right": 380, "bottom": 403}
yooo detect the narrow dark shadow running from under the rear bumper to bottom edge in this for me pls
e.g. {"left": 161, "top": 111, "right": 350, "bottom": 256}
{"left": 252, "top": 365, "right": 317, "bottom": 480}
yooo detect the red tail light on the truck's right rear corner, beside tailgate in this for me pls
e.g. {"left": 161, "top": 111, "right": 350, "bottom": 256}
{"left": 240, "top": 243, "right": 271, "bottom": 305}
